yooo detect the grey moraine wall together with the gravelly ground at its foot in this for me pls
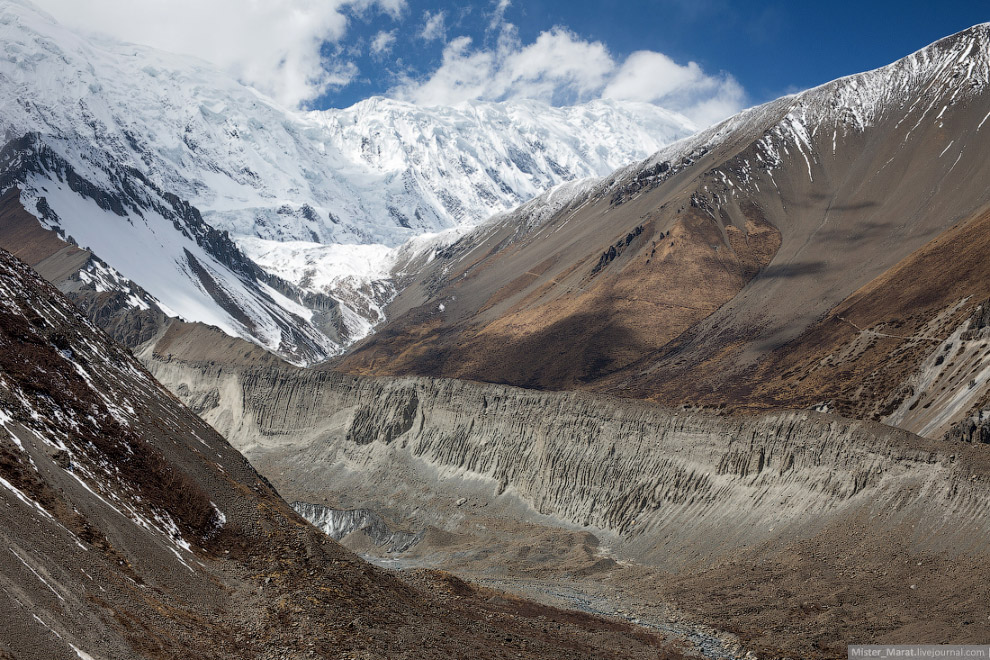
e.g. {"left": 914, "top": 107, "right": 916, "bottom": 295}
{"left": 146, "top": 354, "right": 990, "bottom": 657}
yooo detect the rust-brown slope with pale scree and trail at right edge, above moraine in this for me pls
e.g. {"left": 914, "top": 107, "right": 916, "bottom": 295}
{"left": 612, "top": 202, "right": 990, "bottom": 428}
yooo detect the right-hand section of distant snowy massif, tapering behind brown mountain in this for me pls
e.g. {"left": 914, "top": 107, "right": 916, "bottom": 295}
{"left": 302, "top": 98, "right": 694, "bottom": 240}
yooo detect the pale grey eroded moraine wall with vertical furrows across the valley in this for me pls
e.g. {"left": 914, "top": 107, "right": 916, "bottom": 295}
{"left": 149, "top": 358, "right": 990, "bottom": 567}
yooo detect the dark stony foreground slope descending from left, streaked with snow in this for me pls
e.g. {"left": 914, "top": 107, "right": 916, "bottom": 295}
{"left": 0, "top": 245, "right": 679, "bottom": 659}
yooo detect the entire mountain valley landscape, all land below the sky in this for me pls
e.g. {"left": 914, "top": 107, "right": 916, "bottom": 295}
{"left": 0, "top": 0, "right": 990, "bottom": 660}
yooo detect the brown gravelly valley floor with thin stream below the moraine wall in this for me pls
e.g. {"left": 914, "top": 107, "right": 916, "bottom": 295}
{"left": 308, "top": 484, "right": 990, "bottom": 660}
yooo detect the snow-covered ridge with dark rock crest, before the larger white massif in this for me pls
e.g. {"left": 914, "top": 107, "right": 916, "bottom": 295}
{"left": 0, "top": 134, "right": 340, "bottom": 363}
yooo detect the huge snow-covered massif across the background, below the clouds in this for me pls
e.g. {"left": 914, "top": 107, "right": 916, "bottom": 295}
{"left": 0, "top": 0, "right": 694, "bottom": 246}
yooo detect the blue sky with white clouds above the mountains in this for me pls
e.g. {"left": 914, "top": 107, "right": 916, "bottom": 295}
{"left": 35, "top": 0, "right": 990, "bottom": 125}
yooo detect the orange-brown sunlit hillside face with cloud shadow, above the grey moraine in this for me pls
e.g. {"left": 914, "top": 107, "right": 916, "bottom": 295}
{"left": 344, "top": 193, "right": 779, "bottom": 389}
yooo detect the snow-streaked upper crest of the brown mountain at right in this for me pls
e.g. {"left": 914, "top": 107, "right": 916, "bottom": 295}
{"left": 590, "top": 19, "right": 990, "bottom": 217}
